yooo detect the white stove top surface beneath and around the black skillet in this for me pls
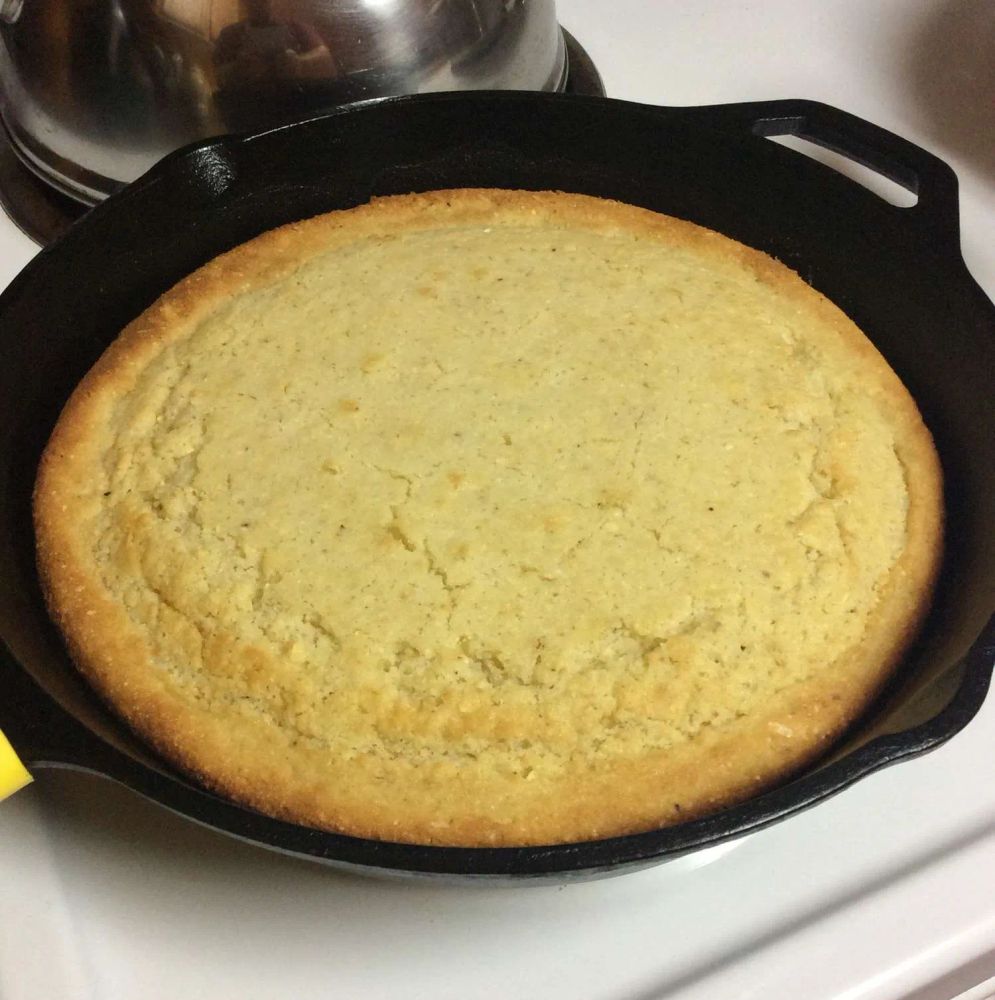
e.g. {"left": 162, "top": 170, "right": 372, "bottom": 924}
{"left": 0, "top": 0, "right": 995, "bottom": 1000}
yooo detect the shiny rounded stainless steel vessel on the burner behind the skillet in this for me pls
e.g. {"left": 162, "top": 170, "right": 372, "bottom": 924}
{"left": 0, "top": 0, "right": 567, "bottom": 203}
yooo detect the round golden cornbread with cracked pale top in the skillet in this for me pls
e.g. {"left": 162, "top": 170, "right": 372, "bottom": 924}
{"left": 35, "top": 190, "right": 942, "bottom": 845}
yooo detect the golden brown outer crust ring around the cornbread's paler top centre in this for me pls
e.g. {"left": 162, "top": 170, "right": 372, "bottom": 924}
{"left": 35, "top": 191, "right": 942, "bottom": 845}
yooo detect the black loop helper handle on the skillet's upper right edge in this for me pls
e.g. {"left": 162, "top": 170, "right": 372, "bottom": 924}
{"left": 702, "top": 100, "right": 960, "bottom": 255}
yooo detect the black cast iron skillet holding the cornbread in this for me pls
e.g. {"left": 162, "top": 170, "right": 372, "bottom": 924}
{"left": 0, "top": 93, "right": 995, "bottom": 879}
